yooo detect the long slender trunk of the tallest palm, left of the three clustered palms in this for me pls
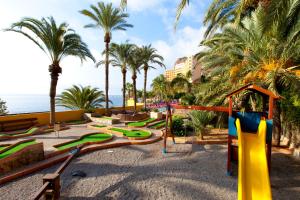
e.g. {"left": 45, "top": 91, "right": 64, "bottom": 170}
{"left": 104, "top": 34, "right": 110, "bottom": 115}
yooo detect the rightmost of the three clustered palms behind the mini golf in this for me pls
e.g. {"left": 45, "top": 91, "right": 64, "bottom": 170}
{"left": 141, "top": 44, "right": 165, "bottom": 109}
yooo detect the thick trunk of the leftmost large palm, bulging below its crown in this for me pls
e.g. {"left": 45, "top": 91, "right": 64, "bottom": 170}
{"left": 49, "top": 64, "right": 62, "bottom": 126}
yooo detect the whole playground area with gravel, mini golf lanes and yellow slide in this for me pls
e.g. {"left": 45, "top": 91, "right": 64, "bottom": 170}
{"left": 0, "top": 85, "right": 300, "bottom": 200}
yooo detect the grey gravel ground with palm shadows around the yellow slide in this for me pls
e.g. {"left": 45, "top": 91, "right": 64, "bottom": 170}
{"left": 0, "top": 142, "right": 300, "bottom": 200}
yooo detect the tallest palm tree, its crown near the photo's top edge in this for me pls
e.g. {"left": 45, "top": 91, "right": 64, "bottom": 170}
{"left": 80, "top": 2, "right": 133, "bottom": 115}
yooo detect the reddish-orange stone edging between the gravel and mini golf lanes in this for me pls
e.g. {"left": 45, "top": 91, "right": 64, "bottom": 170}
{"left": 0, "top": 136, "right": 162, "bottom": 184}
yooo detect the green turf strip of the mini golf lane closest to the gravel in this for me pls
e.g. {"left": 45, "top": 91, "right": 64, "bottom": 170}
{"left": 56, "top": 133, "right": 112, "bottom": 150}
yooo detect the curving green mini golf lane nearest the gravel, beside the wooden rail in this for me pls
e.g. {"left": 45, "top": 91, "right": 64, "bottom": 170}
{"left": 54, "top": 133, "right": 113, "bottom": 150}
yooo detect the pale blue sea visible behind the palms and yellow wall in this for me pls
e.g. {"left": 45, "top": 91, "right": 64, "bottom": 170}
{"left": 0, "top": 94, "right": 122, "bottom": 114}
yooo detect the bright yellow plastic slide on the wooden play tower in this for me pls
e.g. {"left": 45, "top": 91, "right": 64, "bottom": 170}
{"left": 236, "top": 119, "right": 272, "bottom": 200}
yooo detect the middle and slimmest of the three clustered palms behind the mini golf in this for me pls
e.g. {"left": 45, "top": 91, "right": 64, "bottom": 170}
{"left": 128, "top": 47, "right": 143, "bottom": 112}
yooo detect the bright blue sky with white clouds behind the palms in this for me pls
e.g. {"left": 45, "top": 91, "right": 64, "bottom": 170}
{"left": 0, "top": 0, "right": 211, "bottom": 97}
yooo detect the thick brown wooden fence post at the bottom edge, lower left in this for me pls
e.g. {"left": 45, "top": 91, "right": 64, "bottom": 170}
{"left": 43, "top": 173, "right": 60, "bottom": 200}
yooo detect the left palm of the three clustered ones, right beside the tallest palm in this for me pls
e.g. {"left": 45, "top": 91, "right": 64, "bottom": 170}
{"left": 109, "top": 42, "right": 135, "bottom": 112}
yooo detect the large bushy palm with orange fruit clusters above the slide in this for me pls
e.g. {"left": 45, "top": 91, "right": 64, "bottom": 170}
{"left": 200, "top": 0, "right": 300, "bottom": 144}
